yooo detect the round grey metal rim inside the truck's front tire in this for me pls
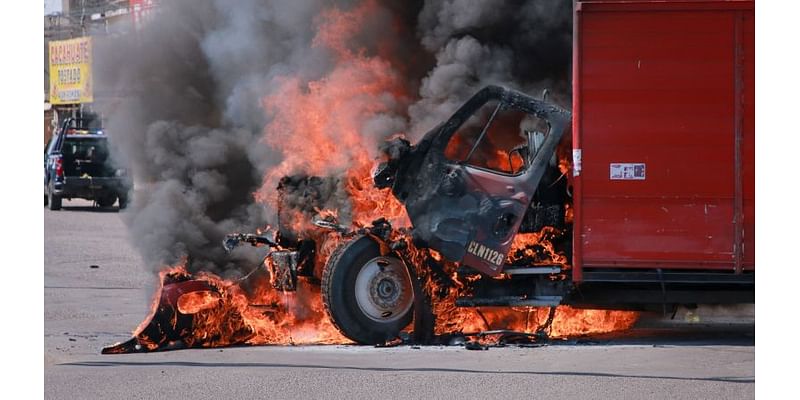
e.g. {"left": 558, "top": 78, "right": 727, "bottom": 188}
{"left": 355, "top": 257, "right": 414, "bottom": 322}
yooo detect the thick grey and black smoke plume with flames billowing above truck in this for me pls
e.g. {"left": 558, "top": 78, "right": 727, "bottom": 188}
{"left": 96, "top": 0, "right": 572, "bottom": 276}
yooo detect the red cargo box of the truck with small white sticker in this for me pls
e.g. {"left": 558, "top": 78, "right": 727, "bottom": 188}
{"left": 573, "top": 1, "right": 755, "bottom": 281}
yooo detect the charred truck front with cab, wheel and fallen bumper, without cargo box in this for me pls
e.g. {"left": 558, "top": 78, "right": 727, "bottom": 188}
{"left": 103, "top": 86, "right": 570, "bottom": 353}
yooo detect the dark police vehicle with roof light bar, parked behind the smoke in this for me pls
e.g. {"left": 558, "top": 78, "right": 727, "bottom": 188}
{"left": 44, "top": 117, "right": 133, "bottom": 210}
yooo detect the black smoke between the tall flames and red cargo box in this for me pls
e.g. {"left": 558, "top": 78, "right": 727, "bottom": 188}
{"left": 409, "top": 0, "right": 572, "bottom": 135}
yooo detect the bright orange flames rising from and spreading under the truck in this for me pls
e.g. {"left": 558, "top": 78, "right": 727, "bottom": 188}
{"left": 137, "top": 0, "right": 636, "bottom": 346}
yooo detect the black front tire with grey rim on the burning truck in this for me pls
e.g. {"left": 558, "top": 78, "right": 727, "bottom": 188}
{"left": 322, "top": 236, "right": 414, "bottom": 345}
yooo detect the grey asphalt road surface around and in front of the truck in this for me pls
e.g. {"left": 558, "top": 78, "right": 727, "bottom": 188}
{"left": 44, "top": 201, "right": 755, "bottom": 400}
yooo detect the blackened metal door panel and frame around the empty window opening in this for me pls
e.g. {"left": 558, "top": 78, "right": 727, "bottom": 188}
{"left": 375, "top": 86, "right": 570, "bottom": 276}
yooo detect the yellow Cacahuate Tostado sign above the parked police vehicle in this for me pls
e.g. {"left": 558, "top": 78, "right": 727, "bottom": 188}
{"left": 49, "top": 37, "right": 93, "bottom": 104}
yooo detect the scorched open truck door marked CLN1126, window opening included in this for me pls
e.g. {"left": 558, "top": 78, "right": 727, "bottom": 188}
{"left": 375, "top": 86, "right": 570, "bottom": 276}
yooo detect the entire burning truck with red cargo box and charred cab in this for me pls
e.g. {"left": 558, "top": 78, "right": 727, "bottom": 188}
{"left": 103, "top": 1, "right": 755, "bottom": 353}
